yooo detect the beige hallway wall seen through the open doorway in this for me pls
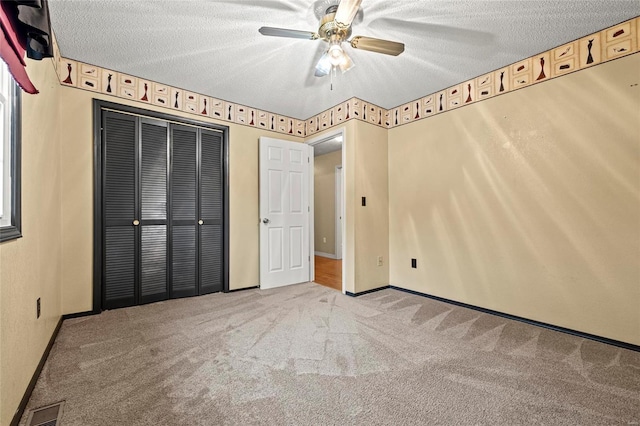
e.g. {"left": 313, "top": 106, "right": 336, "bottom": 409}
{"left": 313, "top": 150, "right": 342, "bottom": 255}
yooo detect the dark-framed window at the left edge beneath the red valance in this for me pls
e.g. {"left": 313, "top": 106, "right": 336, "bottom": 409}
{"left": 0, "top": 62, "right": 22, "bottom": 242}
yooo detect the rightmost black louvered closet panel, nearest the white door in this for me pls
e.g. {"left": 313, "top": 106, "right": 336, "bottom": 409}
{"left": 199, "top": 130, "right": 224, "bottom": 294}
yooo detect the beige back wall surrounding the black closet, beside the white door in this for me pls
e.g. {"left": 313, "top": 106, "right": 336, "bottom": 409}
{"left": 60, "top": 87, "right": 302, "bottom": 314}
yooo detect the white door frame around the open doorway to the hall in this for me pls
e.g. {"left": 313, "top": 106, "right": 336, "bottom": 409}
{"left": 305, "top": 127, "right": 347, "bottom": 294}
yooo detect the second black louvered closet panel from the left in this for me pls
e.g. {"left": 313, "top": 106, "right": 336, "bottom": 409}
{"left": 139, "top": 118, "right": 169, "bottom": 303}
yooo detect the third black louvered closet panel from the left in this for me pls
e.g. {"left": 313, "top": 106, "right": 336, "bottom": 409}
{"left": 171, "top": 124, "right": 199, "bottom": 297}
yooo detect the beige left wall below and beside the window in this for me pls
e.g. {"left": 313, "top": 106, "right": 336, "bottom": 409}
{"left": 0, "top": 60, "right": 62, "bottom": 425}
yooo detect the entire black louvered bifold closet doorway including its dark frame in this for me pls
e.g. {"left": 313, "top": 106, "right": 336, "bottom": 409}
{"left": 93, "top": 100, "right": 229, "bottom": 312}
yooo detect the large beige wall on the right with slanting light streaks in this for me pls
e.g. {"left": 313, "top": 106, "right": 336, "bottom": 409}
{"left": 389, "top": 55, "right": 640, "bottom": 345}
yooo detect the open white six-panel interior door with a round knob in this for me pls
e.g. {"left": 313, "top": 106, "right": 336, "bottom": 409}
{"left": 260, "top": 137, "right": 312, "bottom": 289}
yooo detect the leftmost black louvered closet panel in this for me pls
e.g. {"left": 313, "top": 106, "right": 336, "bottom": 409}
{"left": 102, "top": 112, "right": 137, "bottom": 309}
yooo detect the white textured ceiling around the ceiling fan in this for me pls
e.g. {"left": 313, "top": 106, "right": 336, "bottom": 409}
{"left": 49, "top": 0, "right": 640, "bottom": 119}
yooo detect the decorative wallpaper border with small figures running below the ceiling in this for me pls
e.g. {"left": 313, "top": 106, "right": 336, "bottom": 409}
{"left": 54, "top": 17, "right": 640, "bottom": 138}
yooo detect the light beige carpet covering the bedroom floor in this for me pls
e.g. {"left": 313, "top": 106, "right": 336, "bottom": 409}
{"left": 21, "top": 283, "right": 640, "bottom": 426}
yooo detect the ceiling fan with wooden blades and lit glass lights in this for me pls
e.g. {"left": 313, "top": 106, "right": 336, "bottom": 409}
{"left": 258, "top": 0, "right": 404, "bottom": 77}
